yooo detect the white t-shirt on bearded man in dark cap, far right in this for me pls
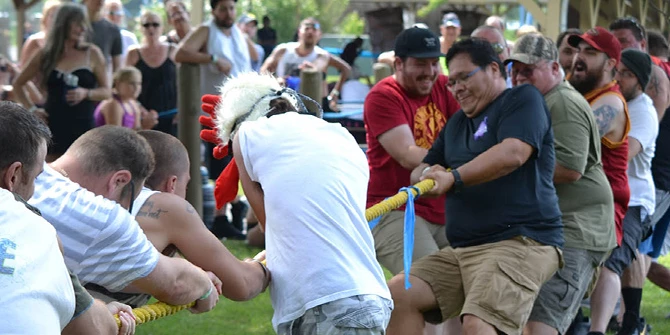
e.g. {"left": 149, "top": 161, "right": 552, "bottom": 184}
{"left": 628, "top": 93, "right": 658, "bottom": 215}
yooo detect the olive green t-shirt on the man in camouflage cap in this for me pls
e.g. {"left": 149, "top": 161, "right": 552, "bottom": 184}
{"left": 544, "top": 81, "right": 616, "bottom": 251}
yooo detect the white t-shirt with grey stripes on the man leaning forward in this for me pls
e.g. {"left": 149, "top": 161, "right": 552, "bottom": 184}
{"left": 28, "top": 164, "right": 159, "bottom": 292}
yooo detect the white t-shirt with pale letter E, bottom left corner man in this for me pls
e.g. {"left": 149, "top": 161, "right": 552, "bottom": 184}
{"left": 0, "top": 189, "right": 75, "bottom": 335}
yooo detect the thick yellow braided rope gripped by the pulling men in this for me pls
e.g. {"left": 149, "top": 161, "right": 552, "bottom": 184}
{"left": 114, "top": 179, "right": 435, "bottom": 326}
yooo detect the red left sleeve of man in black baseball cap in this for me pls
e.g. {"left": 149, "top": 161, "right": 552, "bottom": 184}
{"left": 363, "top": 83, "right": 411, "bottom": 138}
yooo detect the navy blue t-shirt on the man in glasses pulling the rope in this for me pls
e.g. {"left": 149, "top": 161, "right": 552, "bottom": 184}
{"left": 424, "top": 85, "right": 564, "bottom": 248}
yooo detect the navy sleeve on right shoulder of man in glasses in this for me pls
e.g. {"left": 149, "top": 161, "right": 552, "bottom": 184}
{"left": 497, "top": 85, "right": 550, "bottom": 155}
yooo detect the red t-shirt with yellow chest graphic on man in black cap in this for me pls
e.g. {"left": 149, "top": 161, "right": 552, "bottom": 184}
{"left": 363, "top": 75, "right": 460, "bottom": 224}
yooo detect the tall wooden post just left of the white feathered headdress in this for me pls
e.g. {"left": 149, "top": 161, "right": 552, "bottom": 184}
{"left": 177, "top": 63, "right": 203, "bottom": 217}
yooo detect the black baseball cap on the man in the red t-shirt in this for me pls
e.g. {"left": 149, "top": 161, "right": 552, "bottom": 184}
{"left": 393, "top": 27, "right": 444, "bottom": 58}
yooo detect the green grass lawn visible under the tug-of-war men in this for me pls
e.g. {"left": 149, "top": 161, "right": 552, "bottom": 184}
{"left": 136, "top": 241, "right": 670, "bottom": 335}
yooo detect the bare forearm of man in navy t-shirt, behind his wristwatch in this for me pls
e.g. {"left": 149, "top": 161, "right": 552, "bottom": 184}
{"left": 458, "top": 143, "right": 525, "bottom": 186}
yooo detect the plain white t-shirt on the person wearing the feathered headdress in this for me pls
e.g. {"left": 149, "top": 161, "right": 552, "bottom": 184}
{"left": 239, "top": 112, "right": 391, "bottom": 330}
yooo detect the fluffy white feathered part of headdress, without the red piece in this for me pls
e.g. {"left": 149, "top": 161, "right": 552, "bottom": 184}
{"left": 216, "top": 72, "right": 322, "bottom": 143}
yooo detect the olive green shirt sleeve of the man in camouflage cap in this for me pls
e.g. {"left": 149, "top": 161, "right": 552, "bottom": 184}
{"left": 551, "top": 97, "right": 591, "bottom": 174}
